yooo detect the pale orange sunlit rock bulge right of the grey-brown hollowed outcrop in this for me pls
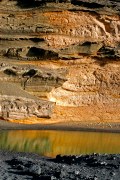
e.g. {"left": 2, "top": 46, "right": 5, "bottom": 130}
{"left": 49, "top": 64, "right": 120, "bottom": 107}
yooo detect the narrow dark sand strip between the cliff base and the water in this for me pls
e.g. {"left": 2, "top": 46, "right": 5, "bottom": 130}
{"left": 0, "top": 120, "right": 120, "bottom": 133}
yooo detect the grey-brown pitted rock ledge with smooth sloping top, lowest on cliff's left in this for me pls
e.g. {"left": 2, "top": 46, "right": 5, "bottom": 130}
{"left": 0, "top": 82, "right": 53, "bottom": 120}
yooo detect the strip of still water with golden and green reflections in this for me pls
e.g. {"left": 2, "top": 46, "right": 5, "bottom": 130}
{"left": 0, "top": 130, "right": 120, "bottom": 157}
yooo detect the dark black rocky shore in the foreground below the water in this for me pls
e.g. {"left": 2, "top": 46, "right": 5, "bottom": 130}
{"left": 0, "top": 151, "right": 120, "bottom": 180}
